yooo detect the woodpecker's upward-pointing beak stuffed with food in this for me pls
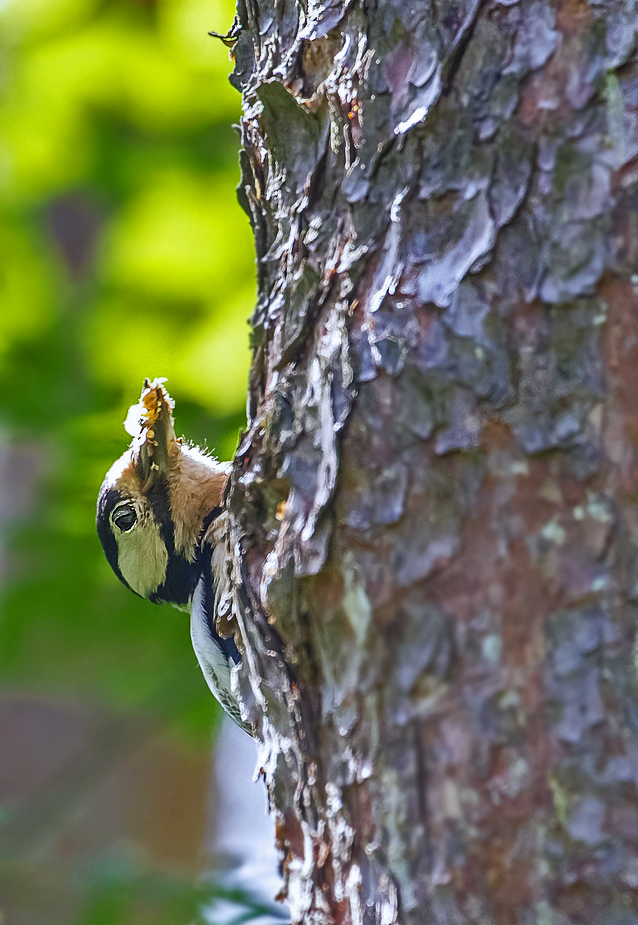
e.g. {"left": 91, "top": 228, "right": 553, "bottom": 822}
{"left": 124, "top": 379, "right": 177, "bottom": 492}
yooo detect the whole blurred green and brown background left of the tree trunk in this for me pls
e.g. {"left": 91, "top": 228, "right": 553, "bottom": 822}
{"left": 0, "top": 0, "right": 255, "bottom": 925}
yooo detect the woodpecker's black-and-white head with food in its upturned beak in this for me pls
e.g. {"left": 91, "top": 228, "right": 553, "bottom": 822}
{"left": 97, "top": 379, "right": 229, "bottom": 606}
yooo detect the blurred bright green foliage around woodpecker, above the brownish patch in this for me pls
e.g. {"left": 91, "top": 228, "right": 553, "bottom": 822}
{"left": 0, "top": 0, "right": 255, "bottom": 922}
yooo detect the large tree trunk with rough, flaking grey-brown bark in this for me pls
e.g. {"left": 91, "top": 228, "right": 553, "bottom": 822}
{"left": 222, "top": 0, "right": 638, "bottom": 925}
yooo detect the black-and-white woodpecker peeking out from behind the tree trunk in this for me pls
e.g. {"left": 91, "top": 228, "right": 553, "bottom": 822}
{"left": 97, "top": 379, "right": 250, "bottom": 732}
